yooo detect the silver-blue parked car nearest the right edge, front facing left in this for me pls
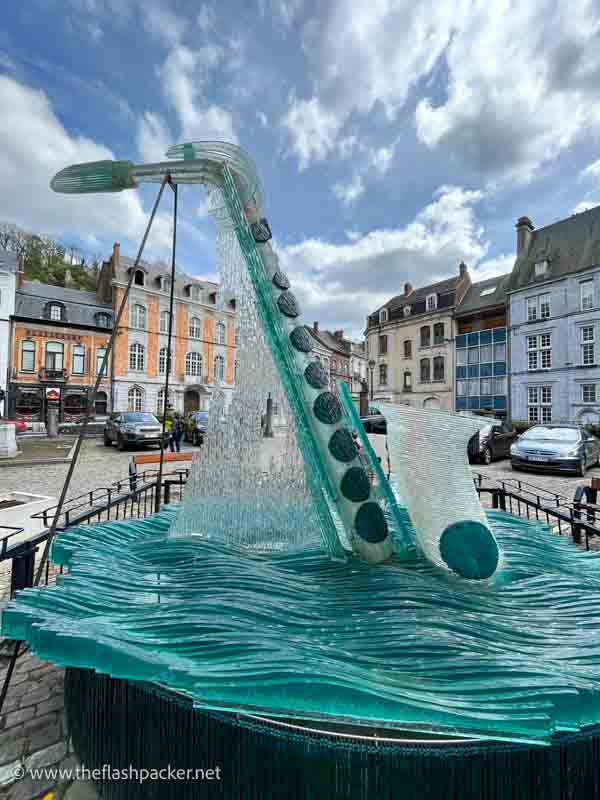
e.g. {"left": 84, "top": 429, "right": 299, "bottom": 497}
{"left": 510, "top": 425, "right": 600, "bottom": 477}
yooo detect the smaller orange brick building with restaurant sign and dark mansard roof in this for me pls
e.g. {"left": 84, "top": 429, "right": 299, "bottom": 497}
{"left": 8, "top": 272, "right": 113, "bottom": 422}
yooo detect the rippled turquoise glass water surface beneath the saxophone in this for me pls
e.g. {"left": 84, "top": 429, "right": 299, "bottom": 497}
{"left": 2, "top": 507, "right": 600, "bottom": 743}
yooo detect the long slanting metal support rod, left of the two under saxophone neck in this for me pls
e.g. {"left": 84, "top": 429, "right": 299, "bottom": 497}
{"left": 0, "top": 175, "right": 172, "bottom": 714}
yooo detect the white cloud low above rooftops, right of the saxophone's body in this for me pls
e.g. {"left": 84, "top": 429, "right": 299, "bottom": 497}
{"left": 278, "top": 186, "right": 490, "bottom": 334}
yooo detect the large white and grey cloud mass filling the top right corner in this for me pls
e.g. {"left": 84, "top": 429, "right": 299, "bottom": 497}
{"left": 284, "top": 0, "right": 600, "bottom": 182}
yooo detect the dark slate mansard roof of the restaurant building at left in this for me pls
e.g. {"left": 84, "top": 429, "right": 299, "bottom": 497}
{"left": 14, "top": 281, "right": 114, "bottom": 330}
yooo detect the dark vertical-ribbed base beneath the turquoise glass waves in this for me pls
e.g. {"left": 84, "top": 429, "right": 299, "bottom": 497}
{"left": 65, "top": 669, "right": 600, "bottom": 800}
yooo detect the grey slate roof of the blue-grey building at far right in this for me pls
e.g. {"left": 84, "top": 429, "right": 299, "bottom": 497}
{"left": 508, "top": 206, "right": 600, "bottom": 292}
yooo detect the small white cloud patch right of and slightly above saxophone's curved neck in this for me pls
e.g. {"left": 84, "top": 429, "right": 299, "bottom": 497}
{"left": 282, "top": 95, "right": 342, "bottom": 171}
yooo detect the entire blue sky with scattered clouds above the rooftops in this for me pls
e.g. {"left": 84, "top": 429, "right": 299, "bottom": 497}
{"left": 0, "top": 0, "right": 600, "bottom": 333}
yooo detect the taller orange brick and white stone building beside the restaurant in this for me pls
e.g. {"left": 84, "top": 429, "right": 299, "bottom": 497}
{"left": 98, "top": 244, "right": 236, "bottom": 413}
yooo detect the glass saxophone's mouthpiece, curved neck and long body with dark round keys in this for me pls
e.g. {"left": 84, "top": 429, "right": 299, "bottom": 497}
{"left": 51, "top": 142, "right": 492, "bottom": 577}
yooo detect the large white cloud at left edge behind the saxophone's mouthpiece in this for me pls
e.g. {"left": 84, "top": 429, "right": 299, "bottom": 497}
{"left": 0, "top": 76, "right": 171, "bottom": 252}
